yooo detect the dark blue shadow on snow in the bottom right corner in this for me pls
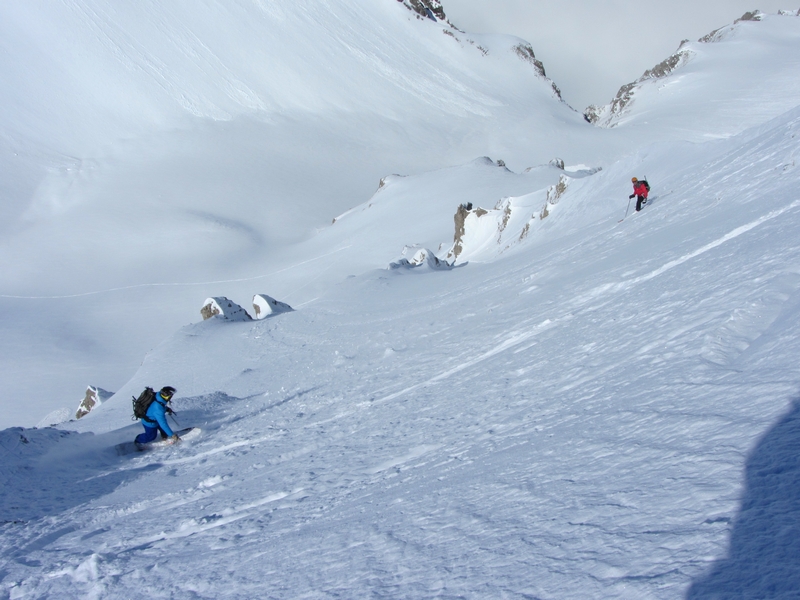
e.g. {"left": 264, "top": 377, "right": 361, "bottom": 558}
{"left": 687, "top": 400, "right": 800, "bottom": 600}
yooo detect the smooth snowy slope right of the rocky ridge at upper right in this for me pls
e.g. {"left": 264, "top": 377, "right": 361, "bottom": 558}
{"left": 587, "top": 12, "right": 800, "bottom": 141}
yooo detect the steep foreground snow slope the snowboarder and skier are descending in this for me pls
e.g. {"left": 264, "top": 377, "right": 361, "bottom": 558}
{"left": 7, "top": 108, "right": 800, "bottom": 600}
